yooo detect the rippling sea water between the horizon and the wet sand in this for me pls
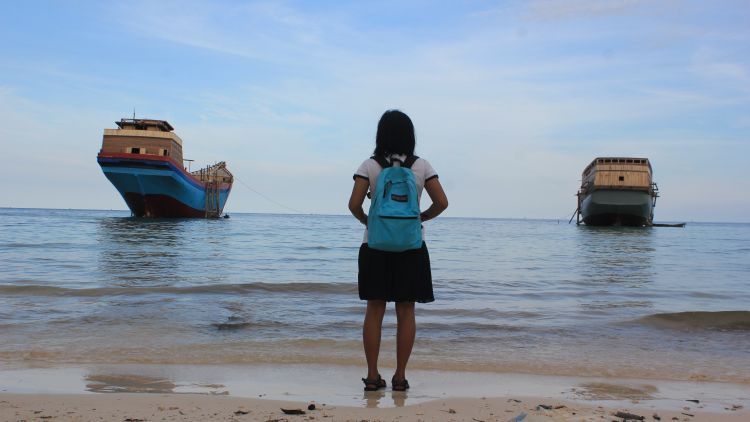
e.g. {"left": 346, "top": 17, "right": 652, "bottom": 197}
{"left": 0, "top": 209, "right": 750, "bottom": 384}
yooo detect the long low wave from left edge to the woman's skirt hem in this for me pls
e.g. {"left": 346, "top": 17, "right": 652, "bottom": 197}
{"left": 0, "top": 282, "right": 357, "bottom": 297}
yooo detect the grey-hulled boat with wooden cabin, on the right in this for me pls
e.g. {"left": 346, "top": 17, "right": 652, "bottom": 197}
{"left": 577, "top": 157, "right": 659, "bottom": 227}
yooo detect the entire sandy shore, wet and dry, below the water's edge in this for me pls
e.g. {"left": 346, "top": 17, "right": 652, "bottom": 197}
{"left": 0, "top": 365, "right": 750, "bottom": 421}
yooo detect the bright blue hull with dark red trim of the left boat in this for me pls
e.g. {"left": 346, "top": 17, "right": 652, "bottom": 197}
{"left": 97, "top": 153, "right": 232, "bottom": 218}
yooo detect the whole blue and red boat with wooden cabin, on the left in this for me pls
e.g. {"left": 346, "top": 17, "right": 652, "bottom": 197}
{"left": 97, "top": 118, "right": 234, "bottom": 217}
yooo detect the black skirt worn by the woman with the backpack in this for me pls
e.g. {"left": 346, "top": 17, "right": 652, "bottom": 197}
{"left": 358, "top": 242, "right": 435, "bottom": 303}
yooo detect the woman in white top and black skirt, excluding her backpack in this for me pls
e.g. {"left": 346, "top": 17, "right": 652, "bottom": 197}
{"left": 349, "top": 110, "right": 448, "bottom": 391}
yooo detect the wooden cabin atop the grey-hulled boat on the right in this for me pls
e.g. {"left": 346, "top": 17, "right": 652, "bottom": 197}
{"left": 581, "top": 157, "right": 653, "bottom": 192}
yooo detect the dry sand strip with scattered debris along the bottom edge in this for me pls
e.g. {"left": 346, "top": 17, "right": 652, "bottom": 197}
{"left": 0, "top": 393, "right": 750, "bottom": 422}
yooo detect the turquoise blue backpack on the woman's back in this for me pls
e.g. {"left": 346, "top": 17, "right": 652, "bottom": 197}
{"left": 367, "top": 155, "right": 422, "bottom": 252}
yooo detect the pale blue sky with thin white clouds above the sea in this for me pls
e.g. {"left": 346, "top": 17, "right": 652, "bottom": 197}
{"left": 0, "top": 0, "right": 750, "bottom": 221}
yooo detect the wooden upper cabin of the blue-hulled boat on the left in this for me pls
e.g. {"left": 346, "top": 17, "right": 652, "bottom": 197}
{"left": 100, "top": 119, "right": 182, "bottom": 166}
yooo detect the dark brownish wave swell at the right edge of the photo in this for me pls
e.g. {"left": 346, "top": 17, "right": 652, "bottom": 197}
{"left": 637, "top": 311, "right": 750, "bottom": 331}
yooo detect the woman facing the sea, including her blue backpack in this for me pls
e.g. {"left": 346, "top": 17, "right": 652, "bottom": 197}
{"left": 349, "top": 110, "right": 448, "bottom": 391}
